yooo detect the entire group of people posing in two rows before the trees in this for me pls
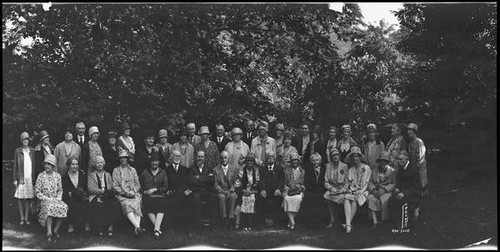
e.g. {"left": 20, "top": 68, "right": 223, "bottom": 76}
{"left": 13, "top": 120, "right": 428, "bottom": 241}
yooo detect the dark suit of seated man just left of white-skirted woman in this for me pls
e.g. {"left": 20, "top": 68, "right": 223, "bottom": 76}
{"left": 257, "top": 163, "right": 285, "bottom": 219}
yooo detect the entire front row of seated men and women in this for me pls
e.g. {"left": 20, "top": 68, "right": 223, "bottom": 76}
{"left": 35, "top": 146, "right": 420, "bottom": 241}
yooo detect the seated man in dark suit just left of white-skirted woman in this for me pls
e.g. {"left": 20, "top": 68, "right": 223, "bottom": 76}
{"left": 257, "top": 152, "right": 285, "bottom": 228}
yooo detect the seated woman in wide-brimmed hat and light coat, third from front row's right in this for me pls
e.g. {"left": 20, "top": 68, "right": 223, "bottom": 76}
{"left": 344, "top": 146, "right": 371, "bottom": 234}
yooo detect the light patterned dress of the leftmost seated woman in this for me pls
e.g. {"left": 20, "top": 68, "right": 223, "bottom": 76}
{"left": 35, "top": 171, "right": 68, "bottom": 227}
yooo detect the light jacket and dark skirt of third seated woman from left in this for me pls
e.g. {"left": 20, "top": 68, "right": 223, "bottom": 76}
{"left": 88, "top": 172, "right": 123, "bottom": 229}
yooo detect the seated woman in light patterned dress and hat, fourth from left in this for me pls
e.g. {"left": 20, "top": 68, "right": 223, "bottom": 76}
{"left": 113, "top": 151, "right": 144, "bottom": 236}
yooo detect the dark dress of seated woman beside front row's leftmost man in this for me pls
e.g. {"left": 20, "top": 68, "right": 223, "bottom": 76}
{"left": 139, "top": 168, "right": 168, "bottom": 214}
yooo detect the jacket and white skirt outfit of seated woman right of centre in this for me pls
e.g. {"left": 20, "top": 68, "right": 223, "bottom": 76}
{"left": 283, "top": 166, "right": 305, "bottom": 213}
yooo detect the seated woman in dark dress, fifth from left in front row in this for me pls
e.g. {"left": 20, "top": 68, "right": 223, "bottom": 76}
{"left": 139, "top": 151, "right": 168, "bottom": 238}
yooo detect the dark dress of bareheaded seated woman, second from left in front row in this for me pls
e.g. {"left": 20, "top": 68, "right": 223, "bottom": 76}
{"left": 62, "top": 171, "right": 90, "bottom": 225}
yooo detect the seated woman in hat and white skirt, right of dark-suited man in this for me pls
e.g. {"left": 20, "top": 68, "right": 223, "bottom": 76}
{"left": 283, "top": 153, "right": 306, "bottom": 230}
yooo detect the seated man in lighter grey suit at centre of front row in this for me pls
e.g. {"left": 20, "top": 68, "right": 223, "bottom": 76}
{"left": 214, "top": 151, "right": 238, "bottom": 230}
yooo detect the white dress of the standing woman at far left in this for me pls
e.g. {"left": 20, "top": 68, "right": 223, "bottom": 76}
{"left": 13, "top": 148, "right": 35, "bottom": 199}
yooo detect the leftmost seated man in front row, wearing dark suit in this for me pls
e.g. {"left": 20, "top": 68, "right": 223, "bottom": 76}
{"left": 166, "top": 150, "right": 194, "bottom": 238}
